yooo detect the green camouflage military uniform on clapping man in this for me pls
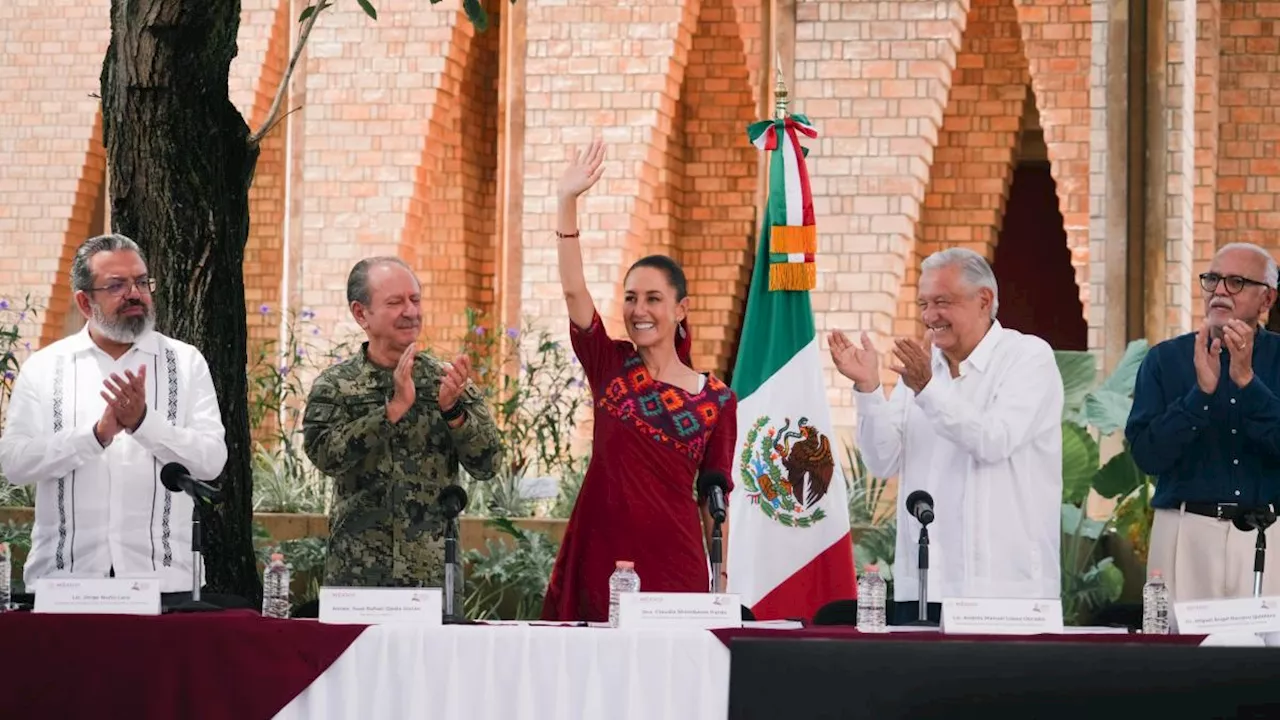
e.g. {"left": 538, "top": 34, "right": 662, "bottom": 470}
{"left": 302, "top": 343, "right": 502, "bottom": 587}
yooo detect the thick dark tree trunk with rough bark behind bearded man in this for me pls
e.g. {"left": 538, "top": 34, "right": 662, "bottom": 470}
{"left": 101, "top": 0, "right": 262, "bottom": 603}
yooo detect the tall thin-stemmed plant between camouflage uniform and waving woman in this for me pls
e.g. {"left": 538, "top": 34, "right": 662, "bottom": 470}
{"left": 462, "top": 307, "right": 589, "bottom": 518}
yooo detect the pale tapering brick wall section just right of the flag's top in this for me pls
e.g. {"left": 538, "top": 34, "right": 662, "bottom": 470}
{"left": 792, "top": 0, "right": 968, "bottom": 428}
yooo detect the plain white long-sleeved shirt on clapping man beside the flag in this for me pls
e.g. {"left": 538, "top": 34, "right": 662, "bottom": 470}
{"left": 854, "top": 322, "right": 1062, "bottom": 602}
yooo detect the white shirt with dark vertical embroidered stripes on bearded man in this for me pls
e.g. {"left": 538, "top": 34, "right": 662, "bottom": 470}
{"left": 0, "top": 329, "right": 227, "bottom": 592}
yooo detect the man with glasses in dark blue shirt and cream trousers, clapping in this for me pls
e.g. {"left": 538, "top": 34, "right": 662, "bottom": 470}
{"left": 1125, "top": 242, "right": 1280, "bottom": 601}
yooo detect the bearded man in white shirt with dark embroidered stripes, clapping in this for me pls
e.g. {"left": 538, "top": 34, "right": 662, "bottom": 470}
{"left": 0, "top": 234, "right": 227, "bottom": 591}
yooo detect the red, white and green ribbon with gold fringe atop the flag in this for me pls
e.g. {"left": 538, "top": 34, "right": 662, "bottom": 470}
{"left": 746, "top": 114, "right": 818, "bottom": 291}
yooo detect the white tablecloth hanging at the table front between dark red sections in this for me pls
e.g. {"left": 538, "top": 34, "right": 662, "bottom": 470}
{"left": 273, "top": 625, "right": 730, "bottom": 720}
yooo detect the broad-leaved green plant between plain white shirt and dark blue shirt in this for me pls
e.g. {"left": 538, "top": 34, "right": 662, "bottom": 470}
{"left": 1055, "top": 340, "right": 1152, "bottom": 623}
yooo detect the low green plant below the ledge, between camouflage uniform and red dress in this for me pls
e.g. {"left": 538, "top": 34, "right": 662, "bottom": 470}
{"left": 462, "top": 518, "right": 559, "bottom": 620}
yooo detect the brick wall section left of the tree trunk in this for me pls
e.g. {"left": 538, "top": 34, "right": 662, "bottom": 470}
{"left": 0, "top": 0, "right": 110, "bottom": 347}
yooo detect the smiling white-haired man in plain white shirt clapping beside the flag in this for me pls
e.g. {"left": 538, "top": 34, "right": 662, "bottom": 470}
{"left": 831, "top": 247, "right": 1062, "bottom": 624}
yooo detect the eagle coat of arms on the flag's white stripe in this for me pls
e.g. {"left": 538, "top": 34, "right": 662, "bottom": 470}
{"left": 739, "top": 415, "right": 836, "bottom": 528}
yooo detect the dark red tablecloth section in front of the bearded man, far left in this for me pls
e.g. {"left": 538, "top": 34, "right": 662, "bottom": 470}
{"left": 0, "top": 610, "right": 365, "bottom": 720}
